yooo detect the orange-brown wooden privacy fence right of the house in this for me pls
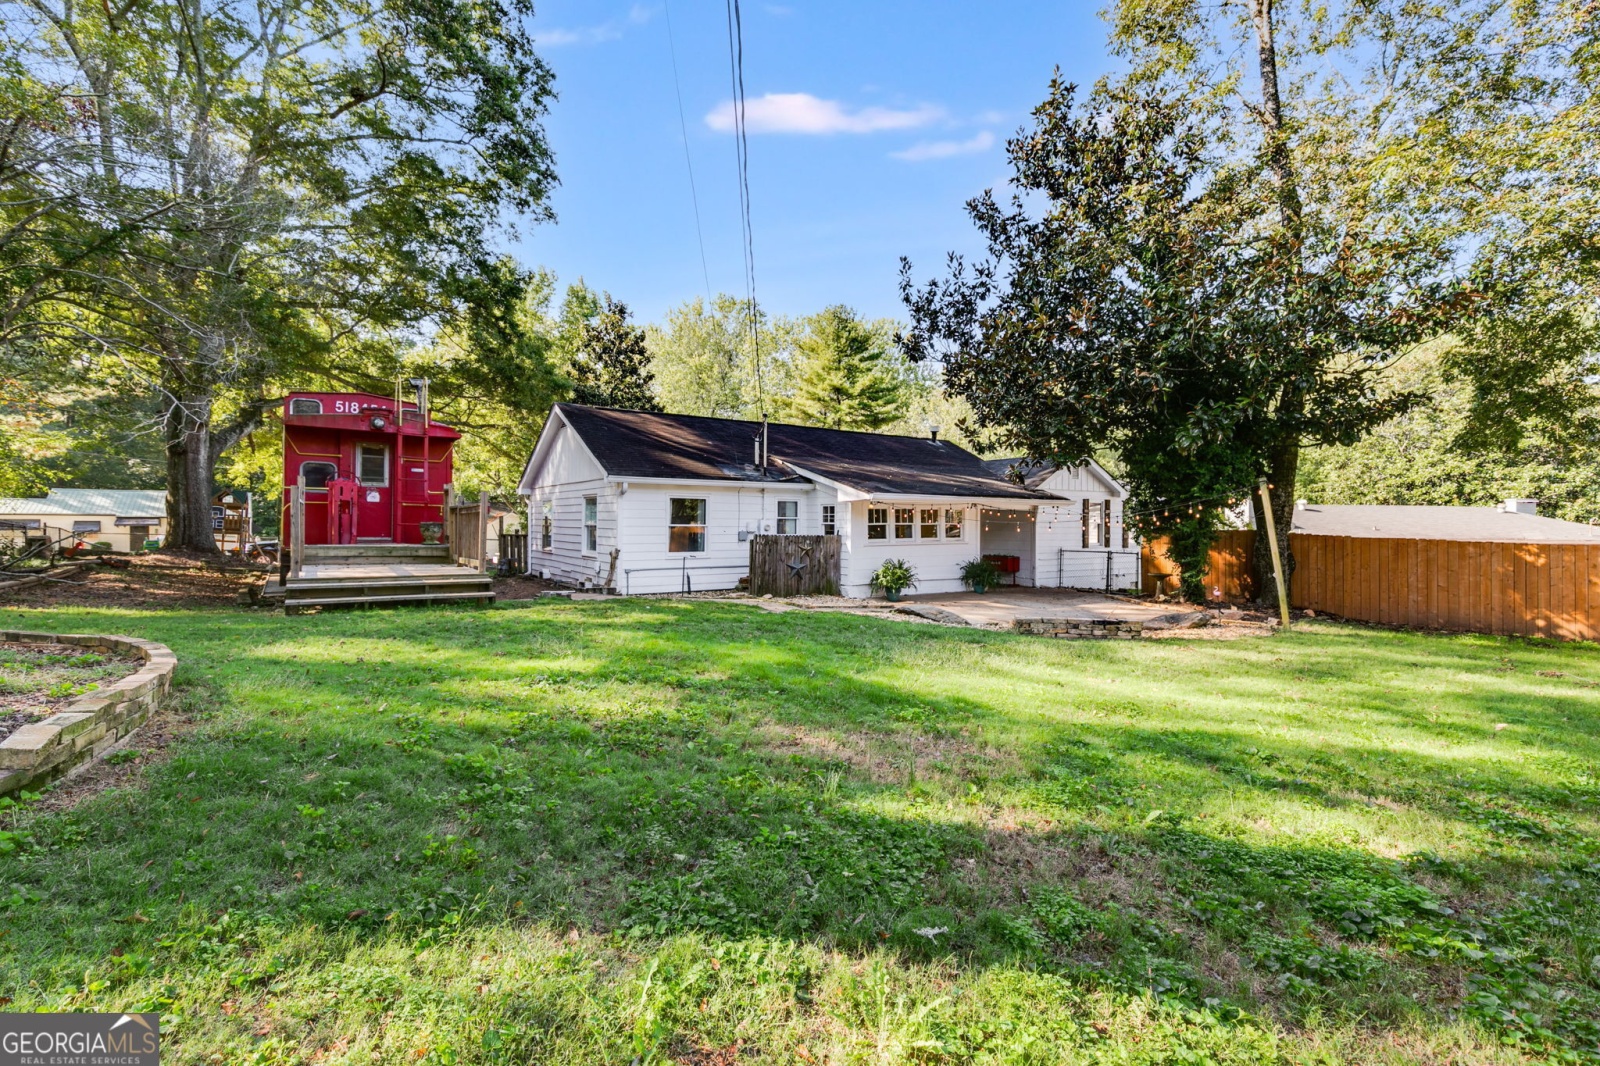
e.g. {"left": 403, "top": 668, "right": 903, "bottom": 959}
{"left": 1144, "top": 530, "right": 1600, "bottom": 640}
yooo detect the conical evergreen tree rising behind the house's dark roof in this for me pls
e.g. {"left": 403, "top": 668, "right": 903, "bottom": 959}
{"left": 782, "top": 304, "right": 906, "bottom": 429}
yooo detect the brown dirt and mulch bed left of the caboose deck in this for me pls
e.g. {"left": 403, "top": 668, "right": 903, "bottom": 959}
{"left": 0, "top": 552, "right": 267, "bottom": 610}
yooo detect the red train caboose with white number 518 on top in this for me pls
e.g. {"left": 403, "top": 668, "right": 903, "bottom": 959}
{"left": 283, "top": 383, "right": 461, "bottom": 544}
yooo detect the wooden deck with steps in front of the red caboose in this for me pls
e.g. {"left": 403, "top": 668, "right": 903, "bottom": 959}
{"left": 264, "top": 544, "right": 494, "bottom": 615}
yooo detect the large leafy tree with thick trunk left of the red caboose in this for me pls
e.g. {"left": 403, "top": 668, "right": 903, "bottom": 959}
{"left": 0, "top": 0, "right": 554, "bottom": 551}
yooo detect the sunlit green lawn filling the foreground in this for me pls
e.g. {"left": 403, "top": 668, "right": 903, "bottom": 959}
{"left": 0, "top": 600, "right": 1600, "bottom": 1064}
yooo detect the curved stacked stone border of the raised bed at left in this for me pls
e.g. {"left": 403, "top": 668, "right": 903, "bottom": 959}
{"left": 0, "top": 629, "right": 178, "bottom": 795}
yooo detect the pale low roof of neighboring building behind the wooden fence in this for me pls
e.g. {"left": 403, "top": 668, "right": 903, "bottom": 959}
{"left": 1293, "top": 499, "right": 1600, "bottom": 544}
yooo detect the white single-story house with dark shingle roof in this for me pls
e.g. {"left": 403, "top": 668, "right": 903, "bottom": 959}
{"left": 517, "top": 403, "right": 1139, "bottom": 597}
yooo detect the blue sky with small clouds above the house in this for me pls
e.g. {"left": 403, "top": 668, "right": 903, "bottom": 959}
{"left": 515, "top": 0, "right": 1114, "bottom": 322}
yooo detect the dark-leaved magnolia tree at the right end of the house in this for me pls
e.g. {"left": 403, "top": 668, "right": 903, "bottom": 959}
{"left": 902, "top": 77, "right": 1450, "bottom": 589}
